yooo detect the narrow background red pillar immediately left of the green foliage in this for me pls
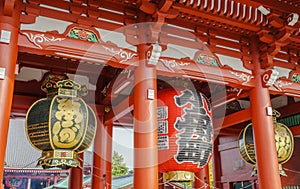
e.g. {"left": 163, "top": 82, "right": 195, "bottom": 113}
{"left": 105, "top": 124, "right": 113, "bottom": 189}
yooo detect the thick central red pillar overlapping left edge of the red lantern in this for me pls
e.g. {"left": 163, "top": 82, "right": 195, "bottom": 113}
{"left": 134, "top": 44, "right": 158, "bottom": 189}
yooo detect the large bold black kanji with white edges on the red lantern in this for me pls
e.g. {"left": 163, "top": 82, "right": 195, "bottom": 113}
{"left": 174, "top": 89, "right": 213, "bottom": 167}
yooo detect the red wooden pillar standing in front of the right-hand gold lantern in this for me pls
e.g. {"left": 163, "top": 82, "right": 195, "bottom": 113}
{"left": 250, "top": 38, "right": 281, "bottom": 189}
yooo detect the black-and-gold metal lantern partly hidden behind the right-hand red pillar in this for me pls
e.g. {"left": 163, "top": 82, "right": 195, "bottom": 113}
{"left": 238, "top": 110, "right": 294, "bottom": 176}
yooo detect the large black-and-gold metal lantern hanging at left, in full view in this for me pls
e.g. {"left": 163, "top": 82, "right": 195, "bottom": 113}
{"left": 26, "top": 75, "right": 97, "bottom": 169}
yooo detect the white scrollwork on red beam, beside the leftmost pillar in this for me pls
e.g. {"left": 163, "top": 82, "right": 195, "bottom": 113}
{"left": 21, "top": 32, "right": 66, "bottom": 49}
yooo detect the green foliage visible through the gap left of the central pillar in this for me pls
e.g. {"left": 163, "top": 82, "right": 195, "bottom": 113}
{"left": 112, "top": 151, "right": 128, "bottom": 177}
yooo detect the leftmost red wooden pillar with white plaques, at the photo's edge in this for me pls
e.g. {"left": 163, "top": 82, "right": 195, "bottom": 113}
{"left": 0, "top": 0, "right": 21, "bottom": 185}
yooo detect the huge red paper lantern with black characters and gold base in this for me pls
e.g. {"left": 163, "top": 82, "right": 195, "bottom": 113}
{"left": 158, "top": 88, "right": 213, "bottom": 181}
